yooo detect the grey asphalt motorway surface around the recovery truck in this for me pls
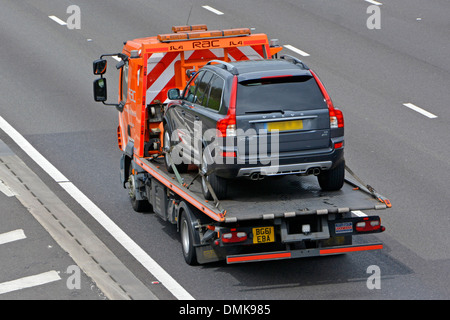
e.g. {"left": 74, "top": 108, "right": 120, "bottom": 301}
{"left": 0, "top": 0, "right": 450, "bottom": 300}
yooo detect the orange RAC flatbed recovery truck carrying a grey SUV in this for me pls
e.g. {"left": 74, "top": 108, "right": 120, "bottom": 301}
{"left": 93, "top": 25, "right": 391, "bottom": 264}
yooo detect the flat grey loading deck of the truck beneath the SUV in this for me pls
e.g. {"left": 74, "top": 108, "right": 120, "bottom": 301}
{"left": 135, "top": 158, "right": 387, "bottom": 222}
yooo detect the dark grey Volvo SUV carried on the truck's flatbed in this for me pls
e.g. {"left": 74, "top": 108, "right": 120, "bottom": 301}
{"left": 163, "top": 56, "right": 345, "bottom": 199}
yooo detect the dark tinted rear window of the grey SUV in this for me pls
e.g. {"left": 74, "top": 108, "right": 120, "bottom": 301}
{"left": 236, "top": 76, "right": 327, "bottom": 115}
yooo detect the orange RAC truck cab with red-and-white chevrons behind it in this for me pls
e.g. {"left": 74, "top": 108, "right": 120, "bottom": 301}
{"left": 114, "top": 25, "right": 281, "bottom": 157}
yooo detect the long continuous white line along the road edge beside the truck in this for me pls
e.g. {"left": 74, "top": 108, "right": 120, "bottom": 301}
{"left": 0, "top": 116, "right": 194, "bottom": 300}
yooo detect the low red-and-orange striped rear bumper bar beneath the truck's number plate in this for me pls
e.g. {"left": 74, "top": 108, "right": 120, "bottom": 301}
{"left": 226, "top": 243, "right": 383, "bottom": 264}
